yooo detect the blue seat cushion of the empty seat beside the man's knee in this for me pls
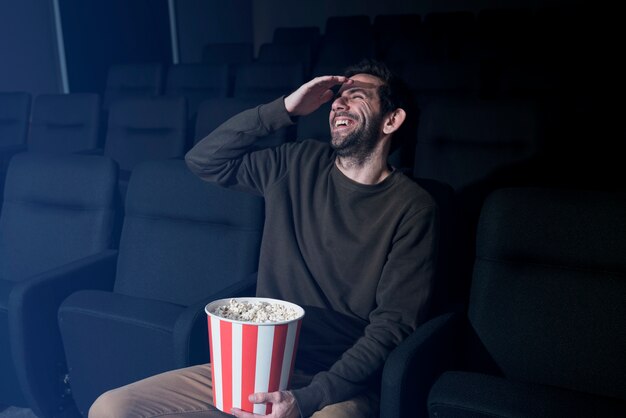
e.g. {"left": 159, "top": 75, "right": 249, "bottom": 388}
{"left": 59, "top": 290, "right": 185, "bottom": 416}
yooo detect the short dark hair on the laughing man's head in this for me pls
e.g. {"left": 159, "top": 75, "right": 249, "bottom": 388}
{"left": 344, "top": 59, "right": 410, "bottom": 115}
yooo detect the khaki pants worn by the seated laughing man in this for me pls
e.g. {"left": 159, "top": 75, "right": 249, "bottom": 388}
{"left": 89, "top": 364, "right": 378, "bottom": 418}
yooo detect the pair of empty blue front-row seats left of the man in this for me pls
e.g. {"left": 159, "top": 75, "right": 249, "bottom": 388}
{"left": 0, "top": 153, "right": 264, "bottom": 417}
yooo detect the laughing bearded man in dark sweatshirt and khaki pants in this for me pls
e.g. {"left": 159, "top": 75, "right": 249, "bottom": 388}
{"left": 90, "top": 61, "right": 437, "bottom": 418}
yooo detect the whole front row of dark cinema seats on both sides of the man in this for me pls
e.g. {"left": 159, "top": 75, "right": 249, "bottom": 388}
{"left": 0, "top": 153, "right": 626, "bottom": 418}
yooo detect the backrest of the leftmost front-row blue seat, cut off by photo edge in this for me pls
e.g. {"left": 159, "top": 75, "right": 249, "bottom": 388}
{"left": 0, "top": 153, "right": 117, "bottom": 281}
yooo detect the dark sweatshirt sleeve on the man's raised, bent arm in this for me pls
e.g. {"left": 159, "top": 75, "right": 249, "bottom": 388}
{"left": 185, "top": 97, "right": 293, "bottom": 195}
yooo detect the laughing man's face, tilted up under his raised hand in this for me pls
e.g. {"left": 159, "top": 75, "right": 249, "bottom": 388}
{"left": 329, "top": 74, "right": 383, "bottom": 159}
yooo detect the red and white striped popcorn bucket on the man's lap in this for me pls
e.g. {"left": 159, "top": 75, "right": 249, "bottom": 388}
{"left": 204, "top": 297, "right": 304, "bottom": 414}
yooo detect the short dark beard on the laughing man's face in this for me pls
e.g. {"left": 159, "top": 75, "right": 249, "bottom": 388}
{"left": 330, "top": 114, "right": 383, "bottom": 165}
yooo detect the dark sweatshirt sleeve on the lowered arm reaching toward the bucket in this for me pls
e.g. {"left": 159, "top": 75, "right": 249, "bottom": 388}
{"left": 292, "top": 206, "right": 438, "bottom": 417}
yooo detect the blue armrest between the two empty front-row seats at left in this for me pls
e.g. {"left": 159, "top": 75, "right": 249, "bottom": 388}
{"left": 8, "top": 250, "right": 117, "bottom": 416}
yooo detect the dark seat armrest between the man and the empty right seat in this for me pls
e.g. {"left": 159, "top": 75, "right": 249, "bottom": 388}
{"left": 380, "top": 312, "right": 466, "bottom": 418}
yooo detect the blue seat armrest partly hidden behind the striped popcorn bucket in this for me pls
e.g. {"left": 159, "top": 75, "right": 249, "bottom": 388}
{"left": 174, "top": 273, "right": 256, "bottom": 367}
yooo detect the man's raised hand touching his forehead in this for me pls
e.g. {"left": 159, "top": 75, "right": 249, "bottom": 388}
{"left": 285, "top": 75, "right": 352, "bottom": 116}
